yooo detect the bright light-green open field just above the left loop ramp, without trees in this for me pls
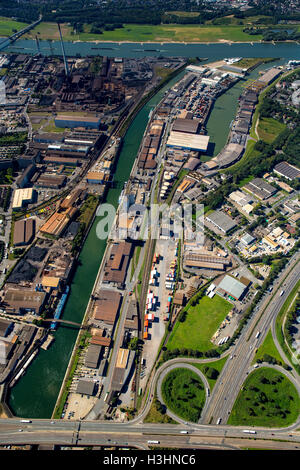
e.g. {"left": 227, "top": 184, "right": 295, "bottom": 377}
{"left": 167, "top": 295, "right": 232, "bottom": 351}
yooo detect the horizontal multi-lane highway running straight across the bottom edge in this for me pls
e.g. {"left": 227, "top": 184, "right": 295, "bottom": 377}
{"left": 0, "top": 418, "right": 300, "bottom": 449}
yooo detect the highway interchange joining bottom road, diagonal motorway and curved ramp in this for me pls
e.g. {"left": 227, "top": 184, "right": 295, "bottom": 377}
{"left": 0, "top": 253, "right": 300, "bottom": 449}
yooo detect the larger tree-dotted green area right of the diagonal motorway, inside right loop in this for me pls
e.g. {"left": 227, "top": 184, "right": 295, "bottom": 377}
{"left": 227, "top": 367, "right": 300, "bottom": 427}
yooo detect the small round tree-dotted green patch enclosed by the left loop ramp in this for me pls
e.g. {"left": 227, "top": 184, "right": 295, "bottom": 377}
{"left": 162, "top": 368, "right": 205, "bottom": 423}
